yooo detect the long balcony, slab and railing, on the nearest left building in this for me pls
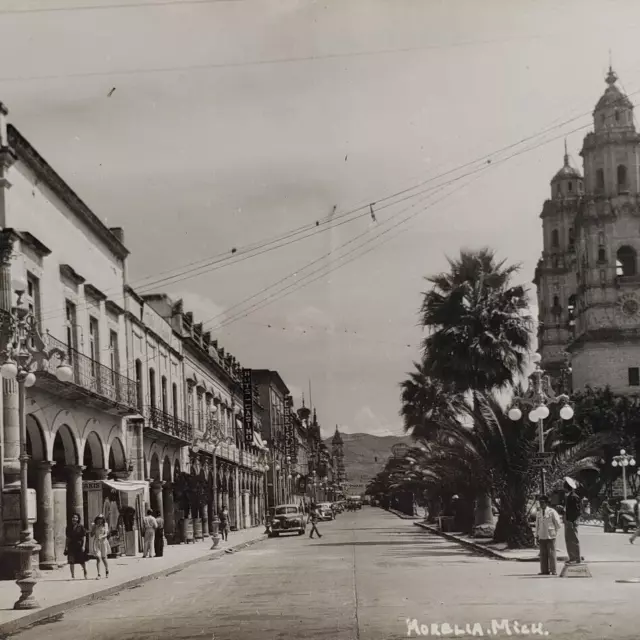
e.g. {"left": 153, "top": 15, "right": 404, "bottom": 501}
{"left": 37, "top": 333, "right": 138, "bottom": 416}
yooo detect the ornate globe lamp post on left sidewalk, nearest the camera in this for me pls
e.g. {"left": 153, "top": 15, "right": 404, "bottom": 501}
{"left": 0, "top": 279, "right": 73, "bottom": 609}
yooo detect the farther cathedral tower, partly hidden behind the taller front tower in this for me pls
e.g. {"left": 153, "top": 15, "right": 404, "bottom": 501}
{"left": 533, "top": 141, "right": 584, "bottom": 376}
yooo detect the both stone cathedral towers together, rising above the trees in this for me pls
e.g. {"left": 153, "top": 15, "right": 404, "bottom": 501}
{"left": 536, "top": 69, "right": 640, "bottom": 393}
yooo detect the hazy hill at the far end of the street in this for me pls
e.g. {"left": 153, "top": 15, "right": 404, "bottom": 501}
{"left": 325, "top": 433, "right": 412, "bottom": 495}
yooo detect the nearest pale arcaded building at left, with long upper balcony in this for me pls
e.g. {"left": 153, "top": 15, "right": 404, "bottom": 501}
{"left": 0, "top": 106, "right": 141, "bottom": 572}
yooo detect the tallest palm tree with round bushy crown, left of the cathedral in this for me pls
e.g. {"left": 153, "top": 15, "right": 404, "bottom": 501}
{"left": 421, "top": 249, "right": 533, "bottom": 535}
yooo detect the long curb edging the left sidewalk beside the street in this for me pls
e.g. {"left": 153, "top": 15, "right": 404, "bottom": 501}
{"left": 0, "top": 534, "right": 267, "bottom": 640}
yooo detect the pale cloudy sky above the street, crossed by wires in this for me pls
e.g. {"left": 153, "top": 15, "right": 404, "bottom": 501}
{"left": 0, "top": 0, "right": 640, "bottom": 435}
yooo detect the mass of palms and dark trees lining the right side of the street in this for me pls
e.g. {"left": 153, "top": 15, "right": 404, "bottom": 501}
{"left": 367, "top": 249, "right": 640, "bottom": 548}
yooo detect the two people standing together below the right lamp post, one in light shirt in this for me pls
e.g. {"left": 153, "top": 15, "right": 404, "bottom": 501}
{"left": 536, "top": 478, "right": 582, "bottom": 576}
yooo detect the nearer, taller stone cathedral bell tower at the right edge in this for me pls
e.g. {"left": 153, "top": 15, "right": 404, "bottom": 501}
{"left": 569, "top": 68, "right": 640, "bottom": 393}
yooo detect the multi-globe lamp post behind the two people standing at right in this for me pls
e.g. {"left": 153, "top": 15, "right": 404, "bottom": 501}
{"left": 508, "top": 353, "right": 573, "bottom": 495}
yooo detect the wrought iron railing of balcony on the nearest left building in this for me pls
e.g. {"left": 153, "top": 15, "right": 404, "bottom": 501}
{"left": 43, "top": 333, "right": 138, "bottom": 408}
